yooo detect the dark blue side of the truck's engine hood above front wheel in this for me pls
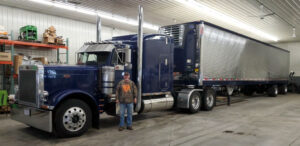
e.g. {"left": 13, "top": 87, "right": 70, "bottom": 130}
{"left": 44, "top": 65, "right": 99, "bottom": 104}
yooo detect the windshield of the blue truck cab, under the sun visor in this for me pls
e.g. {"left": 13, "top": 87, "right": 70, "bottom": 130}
{"left": 77, "top": 52, "right": 111, "bottom": 65}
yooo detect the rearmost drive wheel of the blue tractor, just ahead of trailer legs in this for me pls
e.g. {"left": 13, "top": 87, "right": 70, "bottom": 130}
{"left": 202, "top": 88, "right": 216, "bottom": 111}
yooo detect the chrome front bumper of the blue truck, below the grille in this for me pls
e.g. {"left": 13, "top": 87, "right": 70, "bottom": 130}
{"left": 11, "top": 105, "right": 52, "bottom": 132}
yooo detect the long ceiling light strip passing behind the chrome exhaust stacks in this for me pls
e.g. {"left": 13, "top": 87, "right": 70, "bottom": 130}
{"left": 29, "top": 0, "right": 159, "bottom": 31}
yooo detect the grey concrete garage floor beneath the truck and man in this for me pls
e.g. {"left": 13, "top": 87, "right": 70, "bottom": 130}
{"left": 0, "top": 94, "right": 300, "bottom": 146}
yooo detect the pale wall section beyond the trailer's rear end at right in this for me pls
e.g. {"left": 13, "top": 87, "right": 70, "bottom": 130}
{"left": 273, "top": 42, "right": 300, "bottom": 76}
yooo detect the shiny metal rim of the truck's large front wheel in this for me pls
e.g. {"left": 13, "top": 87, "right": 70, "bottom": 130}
{"left": 63, "top": 107, "right": 86, "bottom": 132}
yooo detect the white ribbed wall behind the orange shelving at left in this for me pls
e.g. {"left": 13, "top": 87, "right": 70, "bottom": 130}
{"left": 0, "top": 5, "right": 134, "bottom": 64}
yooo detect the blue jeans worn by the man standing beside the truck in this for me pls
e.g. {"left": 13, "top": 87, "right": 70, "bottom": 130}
{"left": 120, "top": 103, "right": 133, "bottom": 127}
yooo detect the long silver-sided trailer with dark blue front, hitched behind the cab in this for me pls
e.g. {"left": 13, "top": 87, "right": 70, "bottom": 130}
{"left": 160, "top": 21, "right": 290, "bottom": 111}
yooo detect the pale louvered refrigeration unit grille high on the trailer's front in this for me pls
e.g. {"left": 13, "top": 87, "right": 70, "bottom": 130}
{"left": 160, "top": 24, "right": 184, "bottom": 46}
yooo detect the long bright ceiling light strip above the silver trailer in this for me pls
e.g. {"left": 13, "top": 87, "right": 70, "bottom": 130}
{"left": 176, "top": 0, "right": 279, "bottom": 42}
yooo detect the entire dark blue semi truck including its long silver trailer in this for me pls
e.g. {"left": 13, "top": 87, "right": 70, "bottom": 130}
{"left": 12, "top": 21, "right": 289, "bottom": 137}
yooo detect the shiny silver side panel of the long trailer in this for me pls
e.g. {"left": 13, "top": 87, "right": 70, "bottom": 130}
{"left": 201, "top": 25, "right": 290, "bottom": 80}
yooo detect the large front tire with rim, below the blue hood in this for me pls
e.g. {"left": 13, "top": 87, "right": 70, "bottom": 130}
{"left": 53, "top": 99, "right": 92, "bottom": 137}
